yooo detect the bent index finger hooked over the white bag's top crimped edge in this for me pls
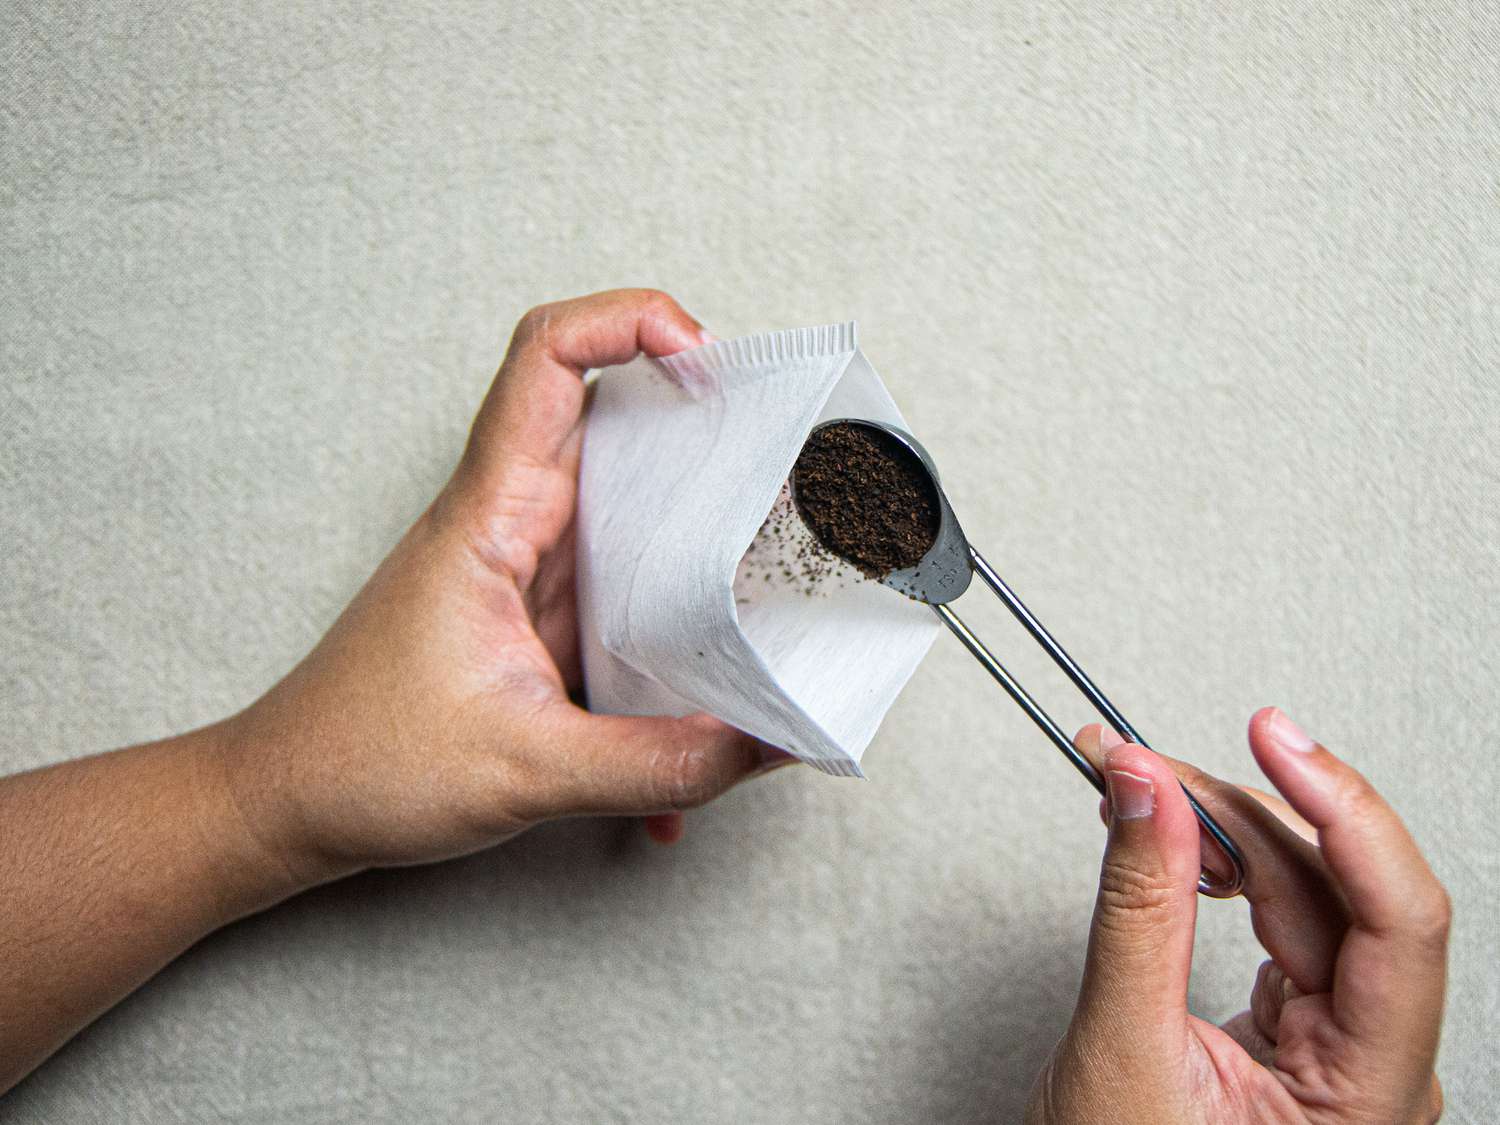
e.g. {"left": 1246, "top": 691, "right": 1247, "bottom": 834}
{"left": 464, "top": 290, "right": 705, "bottom": 473}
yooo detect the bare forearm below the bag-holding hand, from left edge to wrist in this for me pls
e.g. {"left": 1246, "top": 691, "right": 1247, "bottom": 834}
{"left": 0, "top": 728, "right": 302, "bottom": 1091}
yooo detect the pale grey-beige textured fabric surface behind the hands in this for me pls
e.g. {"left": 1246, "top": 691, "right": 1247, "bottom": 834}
{"left": 0, "top": 0, "right": 1500, "bottom": 1125}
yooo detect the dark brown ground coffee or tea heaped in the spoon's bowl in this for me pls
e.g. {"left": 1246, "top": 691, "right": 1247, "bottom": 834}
{"left": 792, "top": 422, "right": 941, "bottom": 579}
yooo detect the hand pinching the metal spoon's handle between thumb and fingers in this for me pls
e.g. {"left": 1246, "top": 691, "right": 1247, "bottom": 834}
{"left": 1026, "top": 708, "right": 1449, "bottom": 1125}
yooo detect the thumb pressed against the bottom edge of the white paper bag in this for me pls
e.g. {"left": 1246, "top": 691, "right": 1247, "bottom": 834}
{"left": 551, "top": 713, "right": 797, "bottom": 816}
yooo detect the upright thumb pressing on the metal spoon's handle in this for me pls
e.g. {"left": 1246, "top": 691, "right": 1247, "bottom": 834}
{"left": 1074, "top": 732, "right": 1199, "bottom": 1065}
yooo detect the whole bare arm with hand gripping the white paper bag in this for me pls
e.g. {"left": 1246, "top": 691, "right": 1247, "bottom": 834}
{"left": 0, "top": 290, "right": 791, "bottom": 1089}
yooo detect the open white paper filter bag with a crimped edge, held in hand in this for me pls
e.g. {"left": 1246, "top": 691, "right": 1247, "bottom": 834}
{"left": 578, "top": 323, "right": 938, "bottom": 777}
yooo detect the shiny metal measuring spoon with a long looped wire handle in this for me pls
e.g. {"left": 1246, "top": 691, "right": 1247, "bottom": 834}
{"left": 792, "top": 419, "right": 1245, "bottom": 899}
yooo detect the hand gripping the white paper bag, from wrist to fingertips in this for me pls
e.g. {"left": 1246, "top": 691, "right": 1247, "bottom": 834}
{"left": 219, "top": 290, "right": 791, "bottom": 884}
